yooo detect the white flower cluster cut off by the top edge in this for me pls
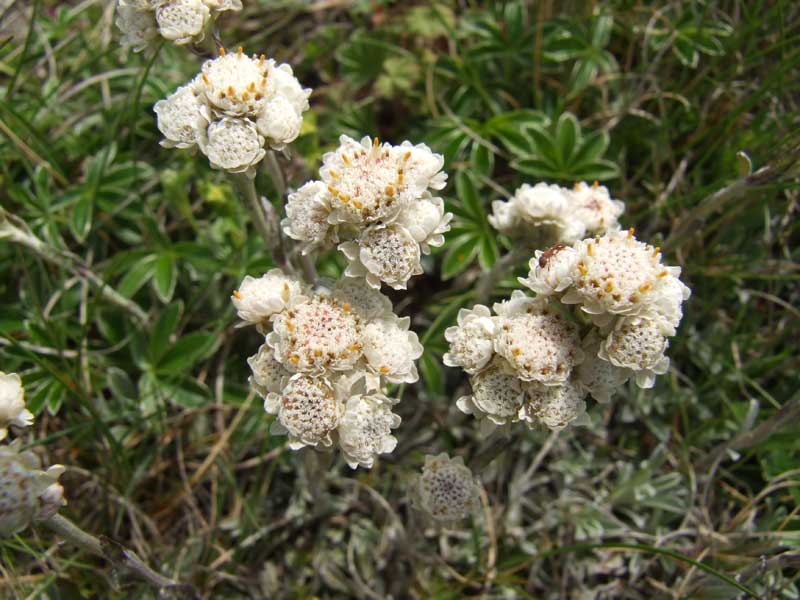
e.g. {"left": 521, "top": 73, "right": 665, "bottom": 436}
{"left": 116, "top": 0, "right": 242, "bottom": 52}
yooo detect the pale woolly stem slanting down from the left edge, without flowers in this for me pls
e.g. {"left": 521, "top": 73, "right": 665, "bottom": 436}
{"left": 0, "top": 208, "right": 148, "bottom": 323}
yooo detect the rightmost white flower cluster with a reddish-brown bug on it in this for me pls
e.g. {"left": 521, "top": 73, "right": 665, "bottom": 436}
{"left": 520, "top": 229, "right": 691, "bottom": 394}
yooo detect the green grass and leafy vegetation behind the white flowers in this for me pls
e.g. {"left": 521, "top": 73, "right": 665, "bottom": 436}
{"left": 0, "top": 0, "right": 800, "bottom": 599}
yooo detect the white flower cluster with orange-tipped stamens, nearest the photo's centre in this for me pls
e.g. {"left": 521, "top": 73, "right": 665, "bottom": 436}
{"left": 282, "top": 135, "right": 452, "bottom": 289}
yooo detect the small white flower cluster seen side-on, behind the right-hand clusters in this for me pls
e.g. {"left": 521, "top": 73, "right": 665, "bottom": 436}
{"left": 489, "top": 182, "right": 625, "bottom": 245}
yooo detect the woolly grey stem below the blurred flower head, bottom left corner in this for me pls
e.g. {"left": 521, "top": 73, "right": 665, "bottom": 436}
{"left": 38, "top": 514, "right": 198, "bottom": 599}
